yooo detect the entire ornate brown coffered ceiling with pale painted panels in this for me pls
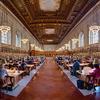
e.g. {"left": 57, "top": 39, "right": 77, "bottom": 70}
{"left": 1, "top": 0, "right": 99, "bottom": 44}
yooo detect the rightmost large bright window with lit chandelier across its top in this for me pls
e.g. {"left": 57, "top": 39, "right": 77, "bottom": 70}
{"left": 89, "top": 26, "right": 100, "bottom": 44}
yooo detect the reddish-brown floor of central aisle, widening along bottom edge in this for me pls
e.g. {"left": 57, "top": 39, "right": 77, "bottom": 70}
{"left": 0, "top": 58, "right": 100, "bottom": 100}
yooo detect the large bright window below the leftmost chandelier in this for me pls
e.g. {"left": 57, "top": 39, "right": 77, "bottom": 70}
{"left": 1, "top": 31, "right": 11, "bottom": 44}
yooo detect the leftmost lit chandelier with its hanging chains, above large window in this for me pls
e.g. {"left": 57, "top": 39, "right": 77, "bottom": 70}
{"left": 0, "top": 11, "right": 11, "bottom": 33}
